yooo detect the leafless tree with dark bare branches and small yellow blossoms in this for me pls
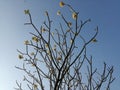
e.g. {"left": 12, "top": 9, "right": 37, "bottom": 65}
{"left": 15, "top": 2, "right": 115, "bottom": 90}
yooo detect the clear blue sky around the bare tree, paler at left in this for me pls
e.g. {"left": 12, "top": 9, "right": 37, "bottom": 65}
{"left": 0, "top": 0, "right": 120, "bottom": 90}
